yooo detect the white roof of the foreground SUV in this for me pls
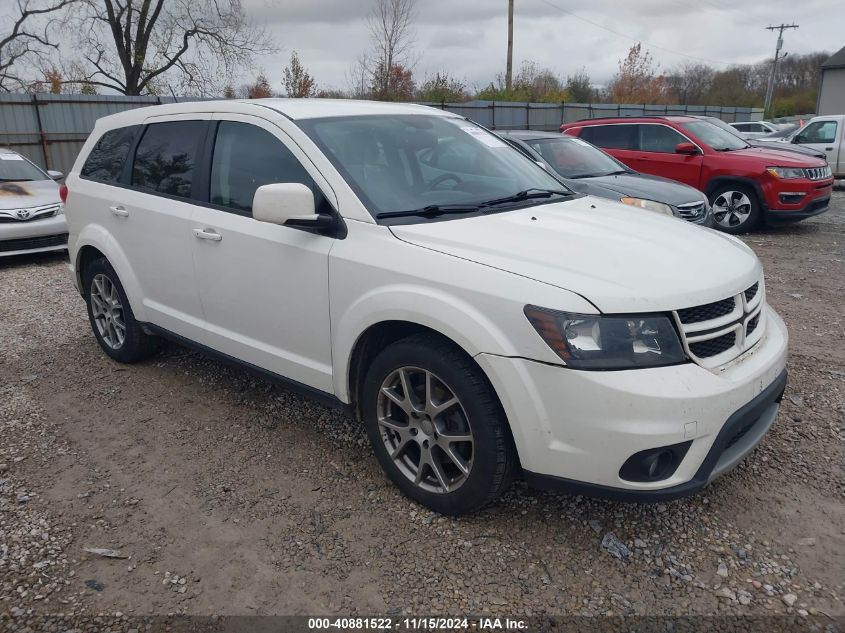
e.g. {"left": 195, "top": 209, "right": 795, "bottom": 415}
{"left": 90, "top": 99, "right": 458, "bottom": 127}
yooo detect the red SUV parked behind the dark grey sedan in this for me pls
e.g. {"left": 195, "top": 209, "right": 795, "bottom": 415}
{"left": 560, "top": 116, "right": 833, "bottom": 233}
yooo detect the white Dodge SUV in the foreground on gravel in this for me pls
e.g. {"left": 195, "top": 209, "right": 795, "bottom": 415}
{"left": 66, "top": 99, "right": 787, "bottom": 514}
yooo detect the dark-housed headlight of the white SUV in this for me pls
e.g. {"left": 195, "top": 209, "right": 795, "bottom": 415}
{"left": 524, "top": 305, "right": 686, "bottom": 369}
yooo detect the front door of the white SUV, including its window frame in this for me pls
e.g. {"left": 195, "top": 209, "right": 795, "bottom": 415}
{"left": 191, "top": 114, "right": 336, "bottom": 393}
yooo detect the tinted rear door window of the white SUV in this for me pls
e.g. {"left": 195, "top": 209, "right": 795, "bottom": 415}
{"left": 132, "top": 121, "right": 206, "bottom": 198}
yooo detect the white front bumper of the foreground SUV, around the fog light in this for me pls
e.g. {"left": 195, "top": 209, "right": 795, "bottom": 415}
{"left": 476, "top": 306, "right": 788, "bottom": 500}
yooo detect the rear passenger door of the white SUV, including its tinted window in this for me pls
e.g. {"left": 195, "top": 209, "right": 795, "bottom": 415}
{"left": 113, "top": 114, "right": 211, "bottom": 341}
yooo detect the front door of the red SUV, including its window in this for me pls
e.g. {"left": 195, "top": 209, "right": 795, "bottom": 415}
{"left": 626, "top": 123, "right": 703, "bottom": 187}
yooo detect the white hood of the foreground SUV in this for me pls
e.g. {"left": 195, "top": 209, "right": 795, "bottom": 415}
{"left": 390, "top": 196, "right": 761, "bottom": 313}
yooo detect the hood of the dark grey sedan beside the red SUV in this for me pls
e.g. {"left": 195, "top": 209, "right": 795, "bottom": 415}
{"left": 566, "top": 173, "right": 704, "bottom": 206}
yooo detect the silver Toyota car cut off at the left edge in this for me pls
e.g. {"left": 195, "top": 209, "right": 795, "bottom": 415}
{"left": 0, "top": 147, "right": 67, "bottom": 257}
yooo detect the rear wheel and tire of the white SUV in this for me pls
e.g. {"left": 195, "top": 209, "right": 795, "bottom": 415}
{"left": 83, "top": 257, "right": 161, "bottom": 363}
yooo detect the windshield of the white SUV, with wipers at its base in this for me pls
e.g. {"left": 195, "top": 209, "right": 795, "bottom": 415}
{"left": 298, "top": 115, "right": 564, "bottom": 217}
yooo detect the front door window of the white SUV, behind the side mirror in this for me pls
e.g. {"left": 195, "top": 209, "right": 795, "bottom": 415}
{"left": 209, "top": 121, "right": 317, "bottom": 213}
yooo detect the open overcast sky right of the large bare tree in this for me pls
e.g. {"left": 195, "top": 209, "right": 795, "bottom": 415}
{"left": 242, "top": 0, "right": 845, "bottom": 90}
